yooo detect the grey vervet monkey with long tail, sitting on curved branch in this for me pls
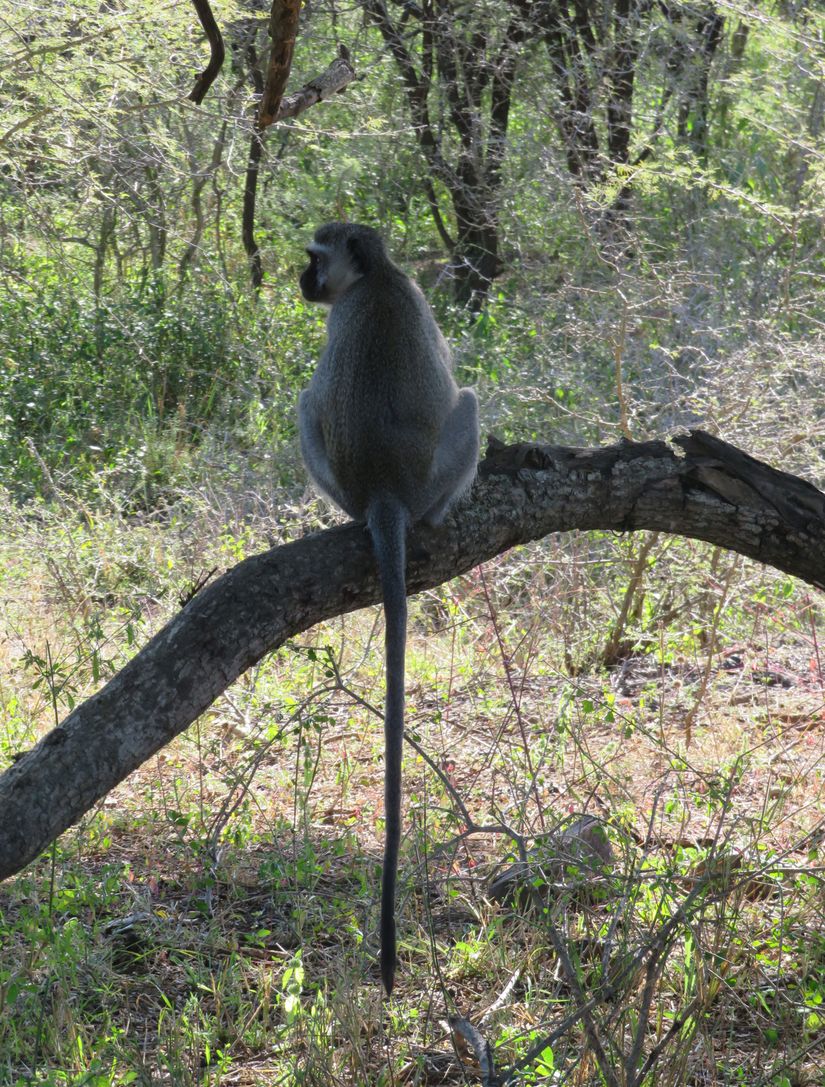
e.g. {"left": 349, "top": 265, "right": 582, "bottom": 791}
{"left": 298, "top": 223, "right": 478, "bottom": 996}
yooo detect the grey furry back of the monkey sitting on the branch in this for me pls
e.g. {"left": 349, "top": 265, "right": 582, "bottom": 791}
{"left": 312, "top": 276, "right": 458, "bottom": 520}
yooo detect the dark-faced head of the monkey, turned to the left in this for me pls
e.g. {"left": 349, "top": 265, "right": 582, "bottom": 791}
{"left": 300, "top": 223, "right": 390, "bottom": 305}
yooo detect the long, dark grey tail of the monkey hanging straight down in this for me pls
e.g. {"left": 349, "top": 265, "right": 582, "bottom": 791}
{"left": 366, "top": 498, "right": 409, "bottom": 996}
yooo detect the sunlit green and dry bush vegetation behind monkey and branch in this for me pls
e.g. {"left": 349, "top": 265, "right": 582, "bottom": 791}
{"left": 0, "top": 0, "right": 825, "bottom": 1087}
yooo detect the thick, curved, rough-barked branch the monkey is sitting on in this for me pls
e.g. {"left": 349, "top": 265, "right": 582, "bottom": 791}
{"left": 0, "top": 430, "right": 825, "bottom": 879}
